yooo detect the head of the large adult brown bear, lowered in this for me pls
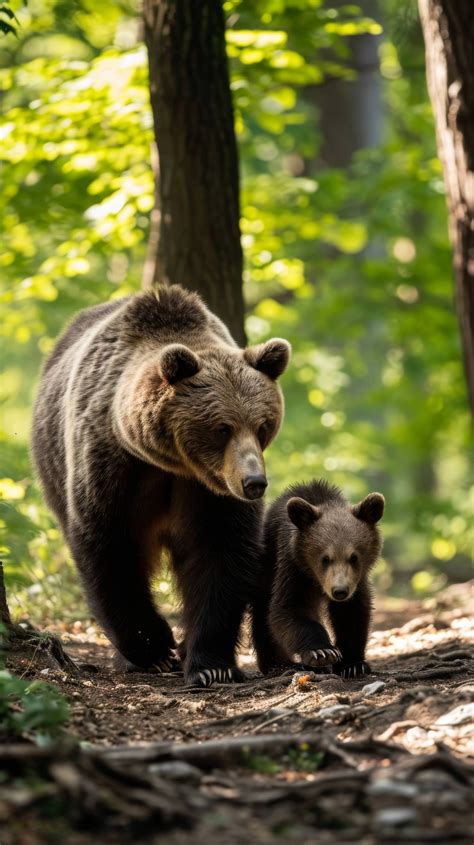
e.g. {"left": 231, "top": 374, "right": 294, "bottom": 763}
{"left": 157, "top": 338, "right": 290, "bottom": 500}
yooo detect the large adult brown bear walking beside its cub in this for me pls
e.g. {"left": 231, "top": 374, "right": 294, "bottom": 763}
{"left": 33, "top": 286, "right": 289, "bottom": 685}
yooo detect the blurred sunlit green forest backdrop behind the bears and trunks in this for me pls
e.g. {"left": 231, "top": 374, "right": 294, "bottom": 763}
{"left": 0, "top": 0, "right": 472, "bottom": 620}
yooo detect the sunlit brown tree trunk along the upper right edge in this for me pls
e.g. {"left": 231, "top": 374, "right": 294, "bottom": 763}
{"left": 419, "top": 0, "right": 474, "bottom": 414}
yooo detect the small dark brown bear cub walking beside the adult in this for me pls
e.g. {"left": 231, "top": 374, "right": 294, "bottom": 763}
{"left": 253, "top": 481, "right": 385, "bottom": 678}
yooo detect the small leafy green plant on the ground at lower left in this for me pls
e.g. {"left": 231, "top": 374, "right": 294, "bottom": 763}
{"left": 0, "top": 669, "right": 69, "bottom": 741}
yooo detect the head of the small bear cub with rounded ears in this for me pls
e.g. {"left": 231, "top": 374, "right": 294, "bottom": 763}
{"left": 287, "top": 493, "right": 385, "bottom": 601}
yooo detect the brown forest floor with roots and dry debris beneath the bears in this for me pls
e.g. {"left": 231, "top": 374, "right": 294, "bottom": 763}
{"left": 0, "top": 584, "right": 474, "bottom": 845}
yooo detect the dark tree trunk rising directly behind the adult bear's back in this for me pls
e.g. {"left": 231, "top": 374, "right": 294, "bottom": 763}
{"left": 143, "top": 0, "right": 245, "bottom": 343}
